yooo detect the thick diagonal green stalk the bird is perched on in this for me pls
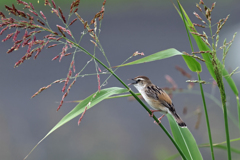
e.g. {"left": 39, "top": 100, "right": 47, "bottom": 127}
{"left": 67, "top": 37, "right": 187, "bottom": 160}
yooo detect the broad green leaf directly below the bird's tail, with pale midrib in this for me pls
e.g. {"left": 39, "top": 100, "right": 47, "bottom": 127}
{"left": 167, "top": 114, "right": 203, "bottom": 160}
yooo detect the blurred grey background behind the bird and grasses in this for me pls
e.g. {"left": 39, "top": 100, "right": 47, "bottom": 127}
{"left": 0, "top": 0, "right": 240, "bottom": 160}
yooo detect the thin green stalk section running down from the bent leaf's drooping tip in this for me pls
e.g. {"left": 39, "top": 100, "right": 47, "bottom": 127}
{"left": 198, "top": 73, "right": 215, "bottom": 160}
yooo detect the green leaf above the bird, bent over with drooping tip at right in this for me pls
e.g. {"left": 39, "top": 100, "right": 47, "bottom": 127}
{"left": 116, "top": 48, "right": 202, "bottom": 72}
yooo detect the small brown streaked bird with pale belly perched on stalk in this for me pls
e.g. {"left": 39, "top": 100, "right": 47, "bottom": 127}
{"left": 129, "top": 76, "right": 187, "bottom": 127}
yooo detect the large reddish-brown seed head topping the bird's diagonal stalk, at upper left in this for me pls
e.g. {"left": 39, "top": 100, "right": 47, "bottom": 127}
{"left": 0, "top": 0, "right": 108, "bottom": 112}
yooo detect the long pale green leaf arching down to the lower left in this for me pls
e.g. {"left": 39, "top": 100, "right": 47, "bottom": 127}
{"left": 25, "top": 87, "right": 128, "bottom": 159}
